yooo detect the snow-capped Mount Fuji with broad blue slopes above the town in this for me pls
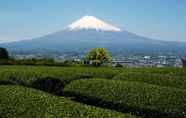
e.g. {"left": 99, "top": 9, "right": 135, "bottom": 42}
{"left": 0, "top": 16, "right": 186, "bottom": 55}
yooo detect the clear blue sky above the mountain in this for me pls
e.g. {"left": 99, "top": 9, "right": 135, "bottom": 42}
{"left": 0, "top": 0, "right": 186, "bottom": 43}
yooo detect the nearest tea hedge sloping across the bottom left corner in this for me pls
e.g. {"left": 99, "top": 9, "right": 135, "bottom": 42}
{"left": 0, "top": 85, "right": 135, "bottom": 118}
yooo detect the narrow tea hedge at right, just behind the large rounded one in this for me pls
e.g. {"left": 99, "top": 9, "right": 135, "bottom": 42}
{"left": 114, "top": 72, "right": 186, "bottom": 89}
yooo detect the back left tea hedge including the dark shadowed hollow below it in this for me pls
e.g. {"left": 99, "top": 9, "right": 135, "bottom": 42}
{"left": 0, "top": 66, "right": 122, "bottom": 95}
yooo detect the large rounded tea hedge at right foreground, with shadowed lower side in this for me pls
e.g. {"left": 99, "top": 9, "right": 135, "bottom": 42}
{"left": 64, "top": 79, "right": 186, "bottom": 118}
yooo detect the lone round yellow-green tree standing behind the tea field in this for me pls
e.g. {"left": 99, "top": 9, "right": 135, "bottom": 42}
{"left": 86, "top": 48, "right": 112, "bottom": 66}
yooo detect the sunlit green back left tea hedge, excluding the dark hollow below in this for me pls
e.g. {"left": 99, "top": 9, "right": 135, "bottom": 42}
{"left": 0, "top": 66, "right": 118, "bottom": 86}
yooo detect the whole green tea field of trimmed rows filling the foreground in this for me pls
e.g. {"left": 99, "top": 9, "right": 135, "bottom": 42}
{"left": 0, "top": 65, "right": 186, "bottom": 118}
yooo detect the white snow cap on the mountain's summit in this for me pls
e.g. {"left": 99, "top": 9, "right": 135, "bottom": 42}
{"left": 66, "top": 16, "right": 121, "bottom": 32}
